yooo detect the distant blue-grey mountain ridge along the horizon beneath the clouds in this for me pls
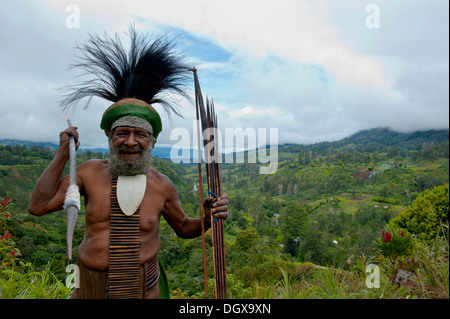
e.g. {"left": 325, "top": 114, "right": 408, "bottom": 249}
{"left": 0, "top": 128, "right": 449, "bottom": 158}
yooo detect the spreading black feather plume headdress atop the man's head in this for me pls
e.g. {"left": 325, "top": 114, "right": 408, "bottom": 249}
{"left": 60, "top": 25, "right": 189, "bottom": 116}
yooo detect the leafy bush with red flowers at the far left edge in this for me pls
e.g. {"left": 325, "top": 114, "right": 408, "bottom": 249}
{"left": 0, "top": 198, "right": 20, "bottom": 269}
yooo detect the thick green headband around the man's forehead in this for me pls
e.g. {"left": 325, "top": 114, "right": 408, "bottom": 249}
{"left": 100, "top": 104, "right": 162, "bottom": 139}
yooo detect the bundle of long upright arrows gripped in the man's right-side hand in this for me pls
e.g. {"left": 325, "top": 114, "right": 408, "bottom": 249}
{"left": 192, "top": 68, "right": 227, "bottom": 299}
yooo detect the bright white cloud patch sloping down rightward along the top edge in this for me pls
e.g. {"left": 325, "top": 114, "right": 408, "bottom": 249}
{"left": 125, "top": 0, "right": 391, "bottom": 87}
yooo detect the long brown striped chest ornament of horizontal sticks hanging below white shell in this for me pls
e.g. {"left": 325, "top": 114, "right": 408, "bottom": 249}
{"left": 108, "top": 174, "right": 141, "bottom": 299}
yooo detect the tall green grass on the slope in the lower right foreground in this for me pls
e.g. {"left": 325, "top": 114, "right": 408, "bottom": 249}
{"left": 237, "top": 232, "right": 449, "bottom": 299}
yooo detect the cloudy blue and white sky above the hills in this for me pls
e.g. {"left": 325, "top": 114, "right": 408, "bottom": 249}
{"left": 0, "top": 0, "right": 449, "bottom": 150}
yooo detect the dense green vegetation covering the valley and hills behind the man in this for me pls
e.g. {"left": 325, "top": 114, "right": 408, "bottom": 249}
{"left": 0, "top": 129, "right": 449, "bottom": 298}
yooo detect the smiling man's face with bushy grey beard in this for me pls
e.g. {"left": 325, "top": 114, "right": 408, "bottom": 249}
{"left": 110, "top": 126, "right": 153, "bottom": 175}
